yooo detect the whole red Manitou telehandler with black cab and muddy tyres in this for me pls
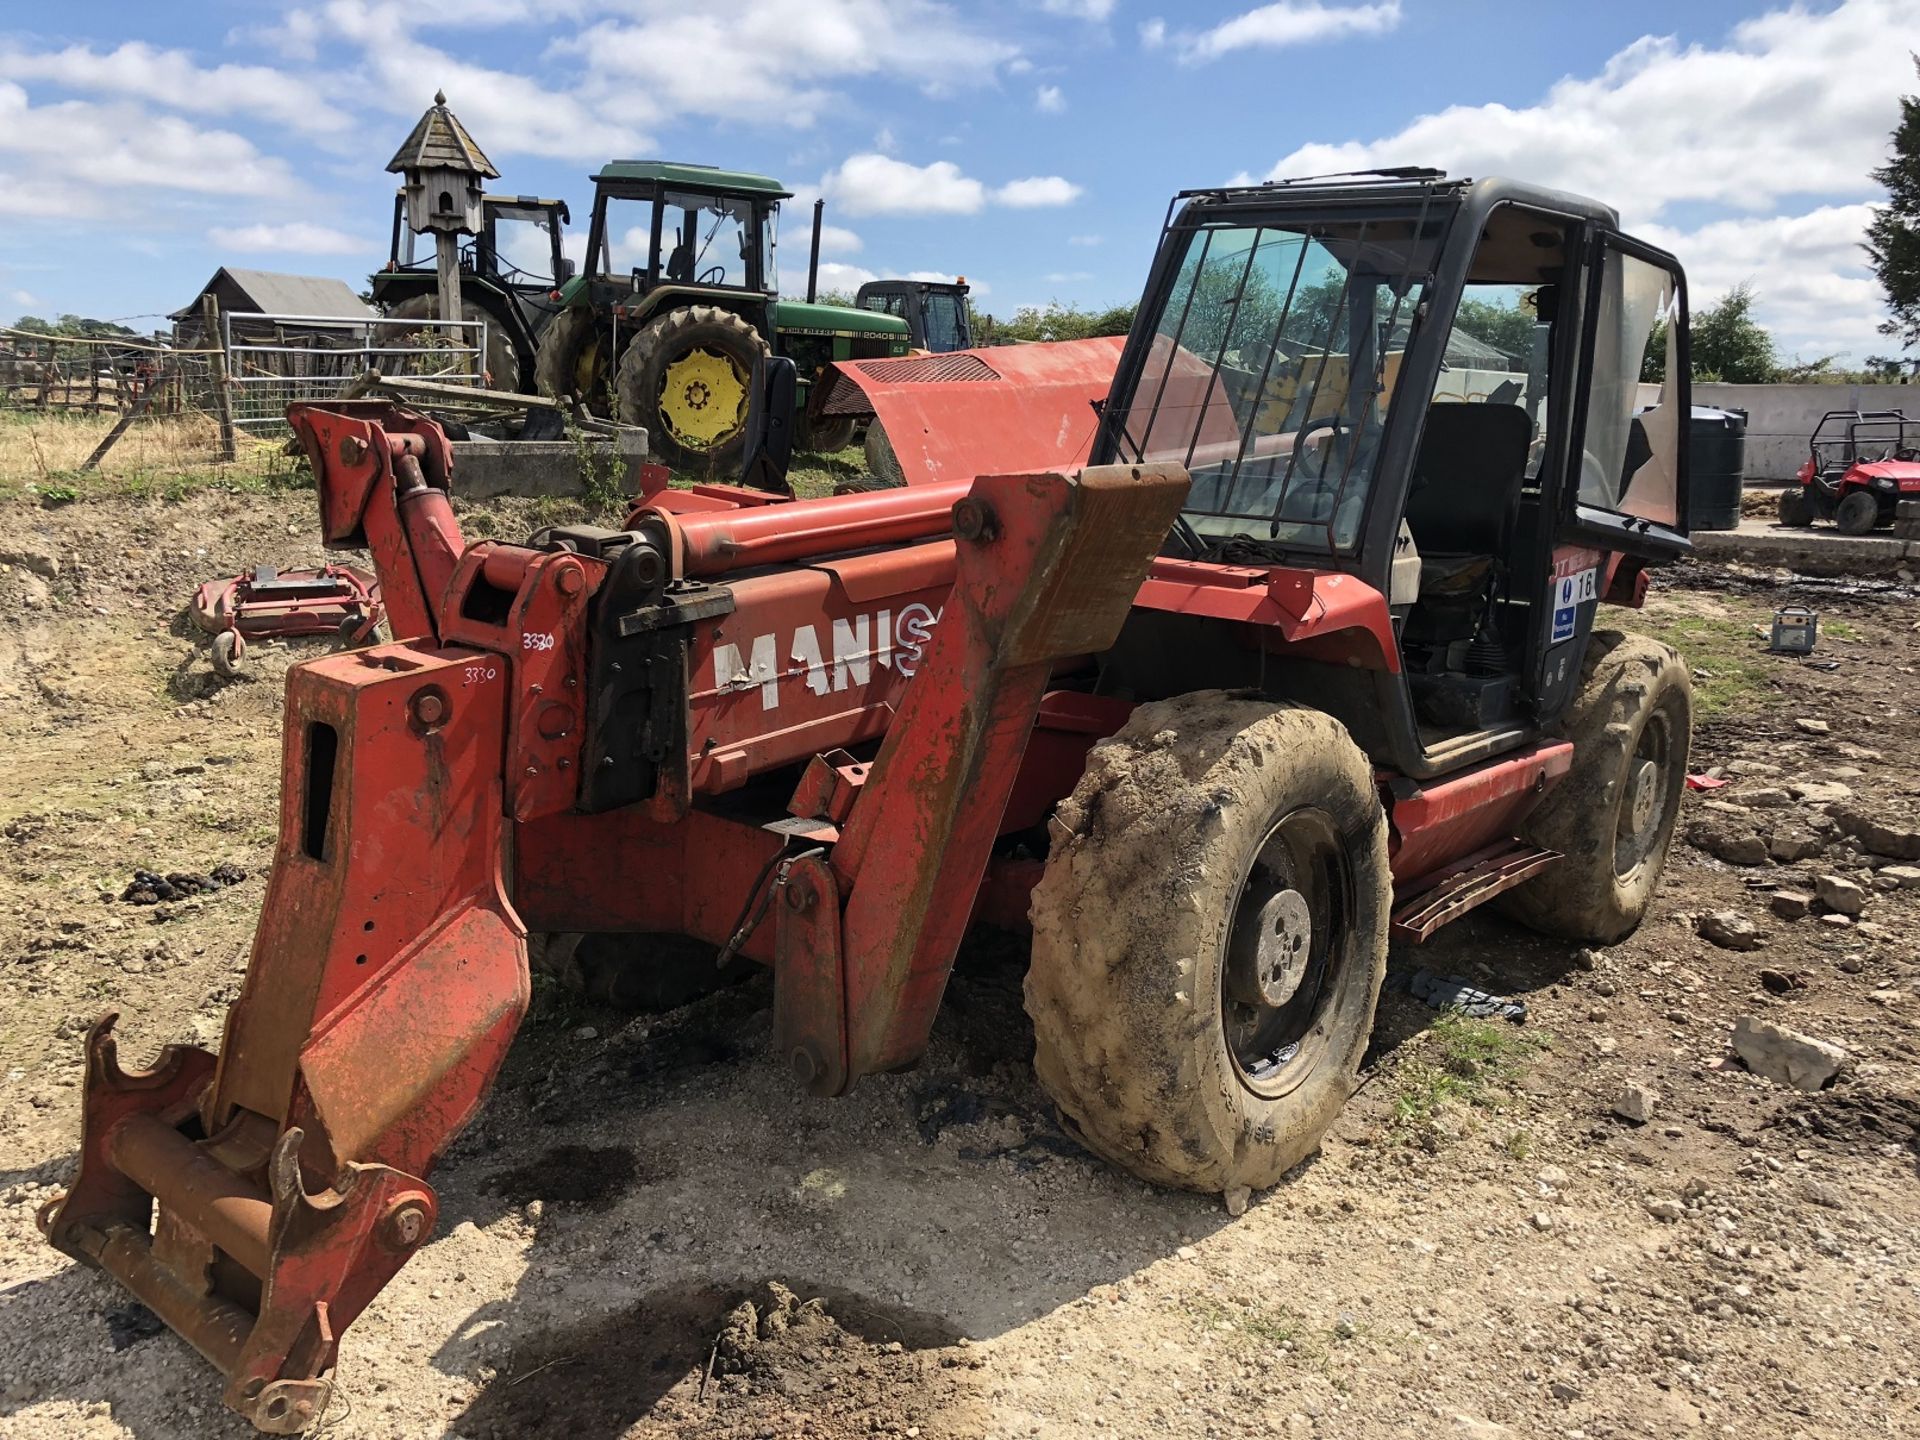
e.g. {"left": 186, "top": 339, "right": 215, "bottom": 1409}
{"left": 40, "top": 171, "right": 1692, "bottom": 1432}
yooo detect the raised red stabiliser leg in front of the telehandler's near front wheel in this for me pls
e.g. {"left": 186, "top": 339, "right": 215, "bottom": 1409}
{"left": 774, "top": 465, "right": 1188, "bottom": 1094}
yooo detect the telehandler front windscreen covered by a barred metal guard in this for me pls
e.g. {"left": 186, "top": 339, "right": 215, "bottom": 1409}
{"left": 1110, "top": 215, "right": 1444, "bottom": 551}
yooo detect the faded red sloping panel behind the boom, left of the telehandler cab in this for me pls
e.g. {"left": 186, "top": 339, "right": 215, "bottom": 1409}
{"left": 818, "top": 336, "right": 1127, "bottom": 486}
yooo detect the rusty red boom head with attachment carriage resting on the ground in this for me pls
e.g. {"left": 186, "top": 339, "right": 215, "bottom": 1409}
{"left": 40, "top": 643, "right": 528, "bottom": 1434}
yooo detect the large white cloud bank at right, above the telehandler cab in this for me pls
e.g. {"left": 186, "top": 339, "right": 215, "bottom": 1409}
{"left": 1269, "top": 0, "right": 1914, "bottom": 357}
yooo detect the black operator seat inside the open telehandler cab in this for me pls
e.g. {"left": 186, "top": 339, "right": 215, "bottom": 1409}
{"left": 1407, "top": 399, "right": 1534, "bottom": 591}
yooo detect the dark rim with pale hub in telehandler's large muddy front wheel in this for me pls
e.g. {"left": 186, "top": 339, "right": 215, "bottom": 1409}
{"left": 1221, "top": 808, "right": 1354, "bottom": 1098}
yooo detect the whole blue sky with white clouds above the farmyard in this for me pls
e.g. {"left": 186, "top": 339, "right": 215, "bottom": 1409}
{"left": 0, "top": 0, "right": 1920, "bottom": 363}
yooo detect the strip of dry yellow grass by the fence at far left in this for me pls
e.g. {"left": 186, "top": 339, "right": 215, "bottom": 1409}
{"left": 0, "top": 411, "right": 290, "bottom": 503}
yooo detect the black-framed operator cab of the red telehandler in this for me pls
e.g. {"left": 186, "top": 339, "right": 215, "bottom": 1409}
{"left": 1092, "top": 171, "right": 1688, "bottom": 776}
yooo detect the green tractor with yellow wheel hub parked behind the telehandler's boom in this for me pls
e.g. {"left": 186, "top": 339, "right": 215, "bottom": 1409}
{"left": 534, "top": 159, "right": 908, "bottom": 474}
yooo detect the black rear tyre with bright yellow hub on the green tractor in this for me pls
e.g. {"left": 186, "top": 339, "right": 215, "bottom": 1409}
{"left": 620, "top": 305, "right": 770, "bottom": 474}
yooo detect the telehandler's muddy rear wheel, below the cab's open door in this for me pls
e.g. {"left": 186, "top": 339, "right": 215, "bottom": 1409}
{"left": 1498, "top": 630, "right": 1693, "bottom": 945}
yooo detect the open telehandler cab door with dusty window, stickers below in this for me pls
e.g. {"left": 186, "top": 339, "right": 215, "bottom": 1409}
{"left": 1534, "top": 232, "right": 1692, "bottom": 718}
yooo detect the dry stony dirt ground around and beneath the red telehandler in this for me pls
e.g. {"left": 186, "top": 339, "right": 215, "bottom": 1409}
{"left": 0, "top": 492, "right": 1920, "bottom": 1440}
